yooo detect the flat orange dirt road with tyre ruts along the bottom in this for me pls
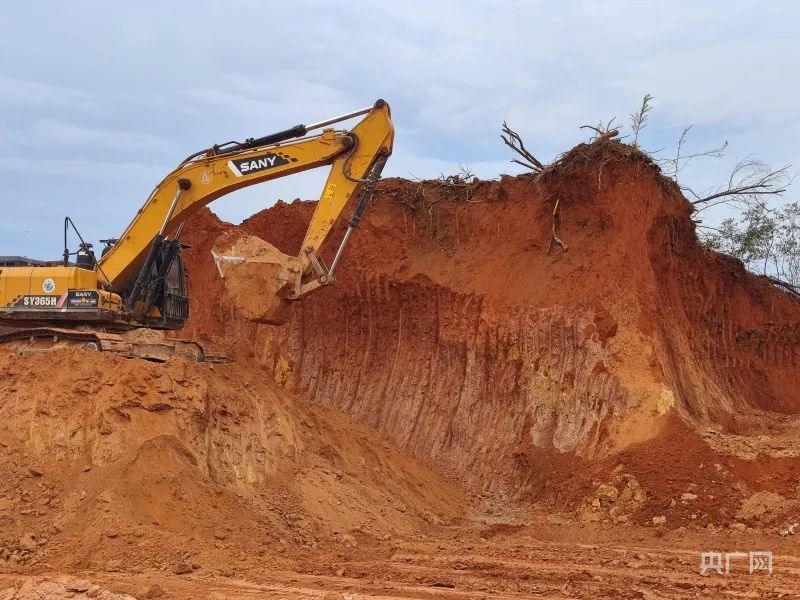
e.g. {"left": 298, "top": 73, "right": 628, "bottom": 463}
{"left": 0, "top": 520, "right": 800, "bottom": 600}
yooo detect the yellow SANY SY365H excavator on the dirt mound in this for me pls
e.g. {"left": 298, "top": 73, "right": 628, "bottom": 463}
{"left": 0, "top": 100, "right": 394, "bottom": 361}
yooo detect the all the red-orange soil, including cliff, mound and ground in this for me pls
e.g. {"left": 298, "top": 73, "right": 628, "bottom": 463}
{"left": 0, "top": 142, "right": 800, "bottom": 600}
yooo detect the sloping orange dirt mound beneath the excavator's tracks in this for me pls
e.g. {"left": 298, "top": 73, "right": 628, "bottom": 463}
{"left": 0, "top": 351, "right": 463, "bottom": 573}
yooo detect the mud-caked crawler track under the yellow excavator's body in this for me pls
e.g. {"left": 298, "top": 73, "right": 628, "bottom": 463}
{"left": 0, "top": 327, "right": 227, "bottom": 363}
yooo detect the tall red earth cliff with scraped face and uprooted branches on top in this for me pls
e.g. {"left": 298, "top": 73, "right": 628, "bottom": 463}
{"left": 180, "top": 142, "right": 800, "bottom": 518}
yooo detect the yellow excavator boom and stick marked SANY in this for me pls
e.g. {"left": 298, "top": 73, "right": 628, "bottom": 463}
{"left": 97, "top": 100, "right": 394, "bottom": 314}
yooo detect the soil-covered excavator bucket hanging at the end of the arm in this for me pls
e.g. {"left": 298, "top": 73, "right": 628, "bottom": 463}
{"left": 211, "top": 236, "right": 301, "bottom": 325}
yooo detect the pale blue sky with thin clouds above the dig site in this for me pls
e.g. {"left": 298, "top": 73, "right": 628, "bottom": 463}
{"left": 0, "top": 0, "right": 800, "bottom": 259}
